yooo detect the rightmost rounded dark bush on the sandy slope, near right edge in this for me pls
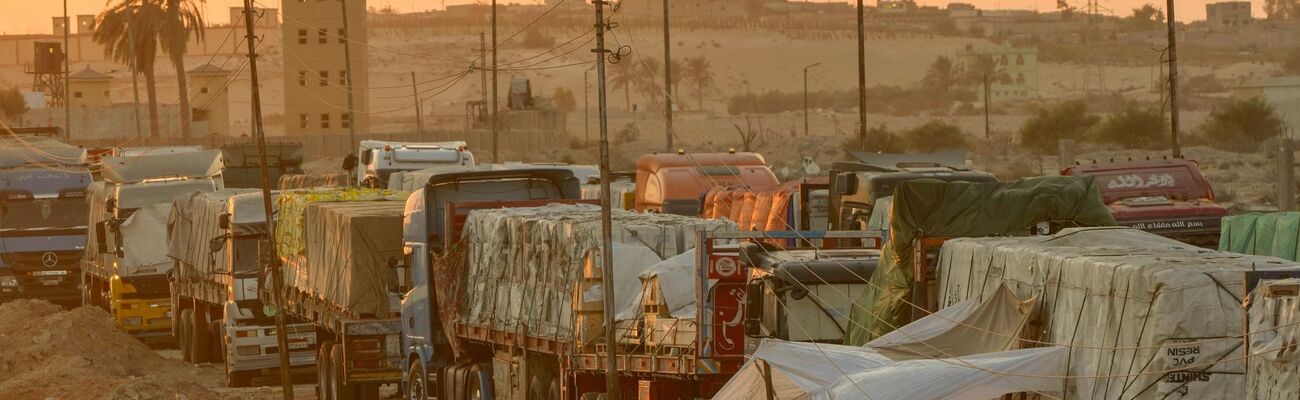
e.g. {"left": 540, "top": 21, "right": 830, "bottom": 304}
{"left": 1201, "top": 97, "right": 1284, "bottom": 152}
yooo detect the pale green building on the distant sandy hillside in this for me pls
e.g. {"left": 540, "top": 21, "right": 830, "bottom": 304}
{"left": 953, "top": 43, "right": 1039, "bottom": 101}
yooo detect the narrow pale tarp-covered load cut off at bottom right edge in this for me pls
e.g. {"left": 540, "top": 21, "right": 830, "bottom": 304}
{"left": 1245, "top": 279, "right": 1300, "bottom": 400}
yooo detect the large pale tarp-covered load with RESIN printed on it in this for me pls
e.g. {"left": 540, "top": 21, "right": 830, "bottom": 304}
{"left": 939, "top": 229, "right": 1296, "bottom": 399}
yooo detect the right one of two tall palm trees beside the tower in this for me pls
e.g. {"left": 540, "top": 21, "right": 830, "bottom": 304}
{"left": 159, "top": 0, "right": 205, "bottom": 138}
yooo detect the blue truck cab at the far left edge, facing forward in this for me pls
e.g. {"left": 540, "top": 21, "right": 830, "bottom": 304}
{"left": 0, "top": 134, "right": 92, "bottom": 306}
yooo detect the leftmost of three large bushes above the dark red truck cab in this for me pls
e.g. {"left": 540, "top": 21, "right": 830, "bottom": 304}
{"left": 1021, "top": 100, "right": 1101, "bottom": 155}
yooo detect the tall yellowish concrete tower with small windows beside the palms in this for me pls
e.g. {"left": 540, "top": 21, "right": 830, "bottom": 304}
{"left": 281, "top": 0, "right": 369, "bottom": 138}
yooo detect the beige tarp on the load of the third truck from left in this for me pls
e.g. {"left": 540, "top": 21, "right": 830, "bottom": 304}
{"left": 166, "top": 188, "right": 256, "bottom": 282}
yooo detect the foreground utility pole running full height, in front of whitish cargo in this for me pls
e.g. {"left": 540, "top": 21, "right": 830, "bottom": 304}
{"left": 592, "top": 0, "right": 621, "bottom": 400}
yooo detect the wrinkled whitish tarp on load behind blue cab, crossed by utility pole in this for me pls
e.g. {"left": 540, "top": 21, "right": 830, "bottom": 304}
{"left": 439, "top": 204, "right": 735, "bottom": 340}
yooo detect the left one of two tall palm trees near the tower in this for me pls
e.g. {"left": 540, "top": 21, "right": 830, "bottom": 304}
{"left": 91, "top": 0, "right": 164, "bottom": 136}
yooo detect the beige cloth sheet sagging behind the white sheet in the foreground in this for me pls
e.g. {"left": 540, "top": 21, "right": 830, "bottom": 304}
{"left": 867, "top": 286, "right": 1037, "bottom": 360}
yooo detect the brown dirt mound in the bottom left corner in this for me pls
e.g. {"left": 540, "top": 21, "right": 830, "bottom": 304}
{"left": 0, "top": 300, "right": 218, "bottom": 400}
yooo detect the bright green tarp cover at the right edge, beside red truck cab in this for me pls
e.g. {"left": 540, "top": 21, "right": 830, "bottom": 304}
{"left": 1219, "top": 212, "right": 1300, "bottom": 261}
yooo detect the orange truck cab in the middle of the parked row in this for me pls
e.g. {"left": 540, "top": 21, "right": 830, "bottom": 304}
{"left": 636, "top": 152, "right": 780, "bottom": 216}
